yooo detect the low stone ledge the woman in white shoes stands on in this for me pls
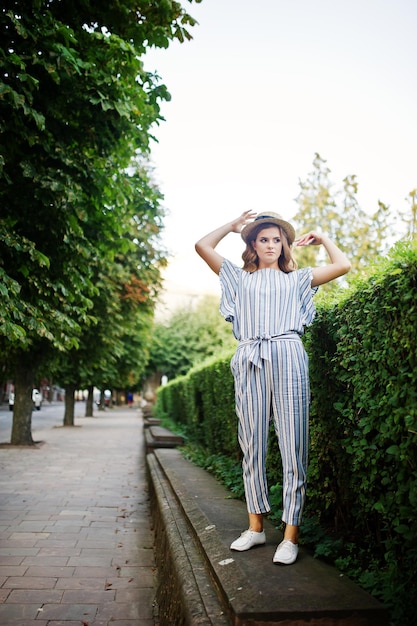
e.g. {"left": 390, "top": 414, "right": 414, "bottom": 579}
{"left": 147, "top": 449, "right": 389, "bottom": 626}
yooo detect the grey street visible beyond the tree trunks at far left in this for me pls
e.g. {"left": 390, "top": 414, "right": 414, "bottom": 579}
{"left": 0, "top": 401, "right": 91, "bottom": 444}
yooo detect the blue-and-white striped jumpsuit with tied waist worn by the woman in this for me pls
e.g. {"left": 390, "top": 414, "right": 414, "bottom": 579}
{"left": 220, "top": 259, "right": 317, "bottom": 526}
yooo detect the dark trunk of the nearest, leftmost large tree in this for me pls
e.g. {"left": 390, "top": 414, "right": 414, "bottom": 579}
{"left": 10, "top": 366, "right": 35, "bottom": 446}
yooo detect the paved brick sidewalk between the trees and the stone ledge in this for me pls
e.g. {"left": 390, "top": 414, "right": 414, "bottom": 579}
{"left": 0, "top": 407, "right": 158, "bottom": 626}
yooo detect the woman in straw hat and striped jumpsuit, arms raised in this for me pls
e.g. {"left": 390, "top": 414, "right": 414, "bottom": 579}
{"left": 195, "top": 211, "right": 350, "bottom": 565}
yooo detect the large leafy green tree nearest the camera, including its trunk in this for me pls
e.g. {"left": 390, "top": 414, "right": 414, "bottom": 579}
{"left": 0, "top": 0, "right": 197, "bottom": 445}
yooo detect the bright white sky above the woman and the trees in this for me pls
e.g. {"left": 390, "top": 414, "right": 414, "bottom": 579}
{"left": 144, "top": 0, "right": 417, "bottom": 308}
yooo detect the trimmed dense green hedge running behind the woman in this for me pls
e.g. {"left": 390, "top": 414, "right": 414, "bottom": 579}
{"left": 156, "top": 242, "right": 417, "bottom": 626}
